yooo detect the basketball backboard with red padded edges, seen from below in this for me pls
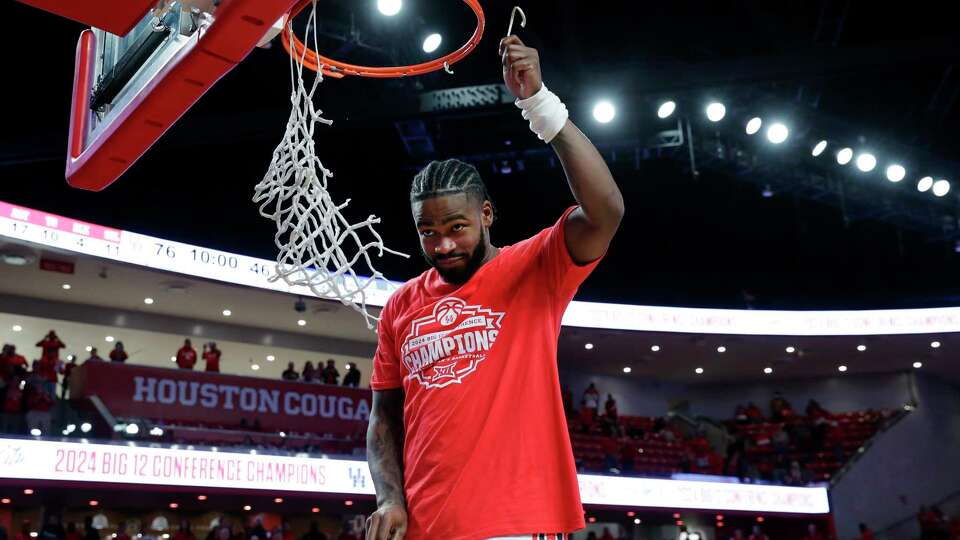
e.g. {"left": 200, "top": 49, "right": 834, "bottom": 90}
{"left": 24, "top": 0, "right": 296, "bottom": 191}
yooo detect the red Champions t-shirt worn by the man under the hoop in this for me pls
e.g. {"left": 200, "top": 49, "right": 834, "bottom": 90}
{"left": 370, "top": 208, "right": 599, "bottom": 540}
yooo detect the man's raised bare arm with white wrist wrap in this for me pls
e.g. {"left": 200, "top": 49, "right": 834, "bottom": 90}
{"left": 500, "top": 36, "right": 624, "bottom": 264}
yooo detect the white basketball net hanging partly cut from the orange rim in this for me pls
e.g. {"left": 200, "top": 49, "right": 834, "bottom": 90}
{"left": 253, "top": 0, "right": 408, "bottom": 329}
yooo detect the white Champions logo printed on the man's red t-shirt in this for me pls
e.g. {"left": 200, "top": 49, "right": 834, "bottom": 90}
{"left": 400, "top": 297, "right": 504, "bottom": 388}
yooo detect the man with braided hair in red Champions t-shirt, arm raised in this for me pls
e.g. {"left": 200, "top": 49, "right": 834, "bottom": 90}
{"left": 366, "top": 36, "right": 623, "bottom": 540}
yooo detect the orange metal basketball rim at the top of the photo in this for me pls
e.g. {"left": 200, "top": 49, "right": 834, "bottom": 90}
{"left": 281, "top": 0, "right": 486, "bottom": 79}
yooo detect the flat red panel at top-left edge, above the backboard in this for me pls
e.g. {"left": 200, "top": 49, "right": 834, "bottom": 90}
{"left": 13, "top": 0, "right": 157, "bottom": 36}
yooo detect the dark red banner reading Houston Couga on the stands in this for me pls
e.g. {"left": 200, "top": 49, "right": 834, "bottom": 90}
{"left": 70, "top": 362, "right": 371, "bottom": 435}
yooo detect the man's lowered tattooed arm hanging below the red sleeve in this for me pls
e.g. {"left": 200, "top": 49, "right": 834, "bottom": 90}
{"left": 366, "top": 388, "right": 407, "bottom": 540}
